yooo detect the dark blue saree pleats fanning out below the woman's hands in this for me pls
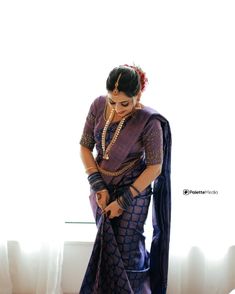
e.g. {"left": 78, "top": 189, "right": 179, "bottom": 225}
{"left": 80, "top": 216, "right": 134, "bottom": 294}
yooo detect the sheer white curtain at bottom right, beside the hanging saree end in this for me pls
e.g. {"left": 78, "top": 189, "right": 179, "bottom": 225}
{"left": 167, "top": 246, "right": 235, "bottom": 294}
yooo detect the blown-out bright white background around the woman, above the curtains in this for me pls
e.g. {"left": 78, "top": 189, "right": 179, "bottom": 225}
{"left": 0, "top": 0, "right": 235, "bottom": 255}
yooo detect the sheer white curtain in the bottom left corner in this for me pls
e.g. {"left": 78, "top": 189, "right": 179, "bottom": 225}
{"left": 0, "top": 232, "right": 64, "bottom": 294}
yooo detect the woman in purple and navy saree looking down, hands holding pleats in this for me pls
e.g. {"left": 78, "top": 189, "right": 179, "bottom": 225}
{"left": 80, "top": 65, "right": 171, "bottom": 294}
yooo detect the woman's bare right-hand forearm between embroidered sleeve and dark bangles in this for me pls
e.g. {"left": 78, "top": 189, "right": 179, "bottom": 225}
{"left": 130, "top": 164, "right": 162, "bottom": 197}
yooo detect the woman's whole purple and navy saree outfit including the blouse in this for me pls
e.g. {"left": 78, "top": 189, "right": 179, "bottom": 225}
{"left": 80, "top": 96, "right": 171, "bottom": 294}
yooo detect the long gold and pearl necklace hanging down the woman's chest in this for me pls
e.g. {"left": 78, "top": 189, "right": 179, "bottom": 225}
{"left": 101, "top": 109, "right": 126, "bottom": 160}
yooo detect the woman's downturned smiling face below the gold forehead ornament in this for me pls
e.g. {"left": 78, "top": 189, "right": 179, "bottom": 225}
{"left": 107, "top": 92, "right": 137, "bottom": 117}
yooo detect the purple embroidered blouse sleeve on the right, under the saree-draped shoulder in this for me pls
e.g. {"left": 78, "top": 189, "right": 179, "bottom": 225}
{"left": 143, "top": 118, "right": 163, "bottom": 165}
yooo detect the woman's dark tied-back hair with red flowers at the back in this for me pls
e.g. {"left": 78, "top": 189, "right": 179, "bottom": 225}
{"left": 106, "top": 65, "right": 147, "bottom": 97}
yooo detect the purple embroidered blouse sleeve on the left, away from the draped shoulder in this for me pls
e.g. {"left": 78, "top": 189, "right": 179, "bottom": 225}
{"left": 80, "top": 102, "right": 95, "bottom": 151}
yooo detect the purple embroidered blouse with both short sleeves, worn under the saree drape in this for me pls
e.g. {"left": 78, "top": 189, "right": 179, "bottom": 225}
{"left": 80, "top": 96, "right": 163, "bottom": 183}
